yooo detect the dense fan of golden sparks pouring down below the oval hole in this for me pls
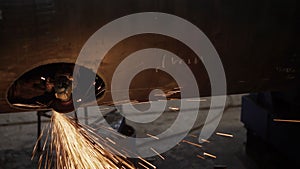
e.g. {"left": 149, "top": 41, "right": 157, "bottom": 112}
{"left": 33, "top": 111, "right": 135, "bottom": 169}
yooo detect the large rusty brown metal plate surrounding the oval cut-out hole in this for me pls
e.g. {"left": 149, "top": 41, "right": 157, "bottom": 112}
{"left": 0, "top": 0, "right": 300, "bottom": 113}
